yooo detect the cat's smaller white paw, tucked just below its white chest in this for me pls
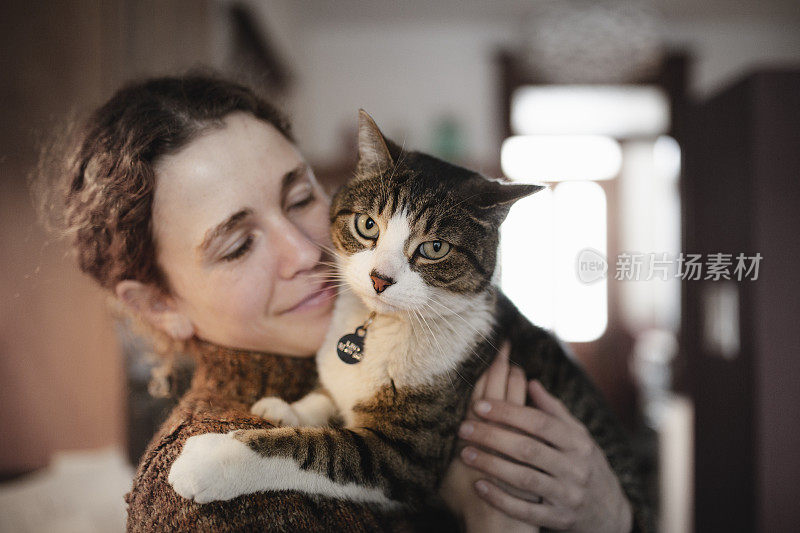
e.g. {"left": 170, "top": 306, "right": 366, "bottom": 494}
{"left": 250, "top": 389, "right": 338, "bottom": 427}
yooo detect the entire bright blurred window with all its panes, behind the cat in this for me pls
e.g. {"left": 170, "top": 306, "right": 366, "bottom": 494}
{"left": 500, "top": 85, "right": 680, "bottom": 342}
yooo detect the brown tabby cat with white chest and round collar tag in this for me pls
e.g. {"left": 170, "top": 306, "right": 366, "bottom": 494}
{"left": 169, "top": 111, "right": 644, "bottom": 528}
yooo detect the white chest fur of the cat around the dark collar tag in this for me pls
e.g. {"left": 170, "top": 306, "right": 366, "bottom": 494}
{"left": 317, "top": 293, "right": 493, "bottom": 424}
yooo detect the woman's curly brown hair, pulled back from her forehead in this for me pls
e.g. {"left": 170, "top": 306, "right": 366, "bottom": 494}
{"left": 31, "top": 71, "right": 293, "bottom": 390}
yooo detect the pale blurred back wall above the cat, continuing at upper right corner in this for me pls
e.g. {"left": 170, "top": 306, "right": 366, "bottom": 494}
{"left": 249, "top": 0, "right": 800, "bottom": 167}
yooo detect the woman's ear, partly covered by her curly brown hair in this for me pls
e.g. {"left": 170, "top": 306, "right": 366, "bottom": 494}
{"left": 114, "top": 279, "right": 194, "bottom": 340}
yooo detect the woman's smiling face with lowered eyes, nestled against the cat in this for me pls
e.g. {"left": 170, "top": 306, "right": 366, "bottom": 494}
{"left": 153, "top": 113, "right": 335, "bottom": 356}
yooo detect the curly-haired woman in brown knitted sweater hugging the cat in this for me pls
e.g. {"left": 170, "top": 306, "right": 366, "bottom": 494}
{"left": 45, "top": 75, "right": 649, "bottom": 532}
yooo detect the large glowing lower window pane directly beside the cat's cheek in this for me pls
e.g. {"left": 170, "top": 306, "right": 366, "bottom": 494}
{"left": 500, "top": 181, "right": 608, "bottom": 342}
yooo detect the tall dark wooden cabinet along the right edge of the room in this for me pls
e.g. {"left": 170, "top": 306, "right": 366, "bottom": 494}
{"left": 679, "top": 70, "right": 800, "bottom": 532}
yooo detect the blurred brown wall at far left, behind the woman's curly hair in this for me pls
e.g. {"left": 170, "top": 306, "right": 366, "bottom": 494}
{"left": 0, "top": 0, "right": 216, "bottom": 476}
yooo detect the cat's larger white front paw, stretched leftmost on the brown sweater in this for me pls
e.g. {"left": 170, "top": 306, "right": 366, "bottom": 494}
{"left": 167, "top": 432, "right": 255, "bottom": 503}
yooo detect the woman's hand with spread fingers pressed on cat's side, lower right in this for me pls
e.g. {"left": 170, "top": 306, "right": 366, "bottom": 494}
{"left": 459, "top": 356, "right": 632, "bottom": 533}
